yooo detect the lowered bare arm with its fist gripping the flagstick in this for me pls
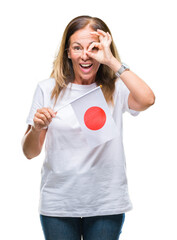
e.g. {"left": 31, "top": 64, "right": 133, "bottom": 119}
{"left": 22, "top": 108, "right": 56, "bottom": 159}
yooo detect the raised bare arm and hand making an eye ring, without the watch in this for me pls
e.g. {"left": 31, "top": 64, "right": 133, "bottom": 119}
{"left": 87, "top": 29, "right": 155, "bottom": 111}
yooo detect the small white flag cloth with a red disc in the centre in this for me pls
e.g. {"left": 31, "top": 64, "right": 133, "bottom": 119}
{"left": 70, "top": 87, "right": 118, "bottom": 147}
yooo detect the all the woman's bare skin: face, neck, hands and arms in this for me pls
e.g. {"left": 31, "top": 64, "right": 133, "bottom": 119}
{"left": 22, "top": 25, "right": 155, "bottom": 159}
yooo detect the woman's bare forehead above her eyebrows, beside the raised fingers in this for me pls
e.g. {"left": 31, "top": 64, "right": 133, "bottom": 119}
{"left": 70, "top": 26, "right": 99, "bottom": 44}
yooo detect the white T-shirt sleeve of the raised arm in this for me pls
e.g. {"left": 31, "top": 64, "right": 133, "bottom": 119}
{"left": 121, "top": 80, "right": 140, "bottom": 116}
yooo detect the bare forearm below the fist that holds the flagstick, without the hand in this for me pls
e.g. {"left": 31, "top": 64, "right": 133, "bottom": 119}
{"left": 22, "top": 127, "right": 43, "bottom": 159}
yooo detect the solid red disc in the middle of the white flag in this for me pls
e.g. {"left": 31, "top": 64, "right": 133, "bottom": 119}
{"left": 84, "top": 107, "right": 106, "bottom": 130}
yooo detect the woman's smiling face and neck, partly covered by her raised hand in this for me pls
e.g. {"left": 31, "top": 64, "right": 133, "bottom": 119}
{"left": 68, "top": 26, "right": 100, "bottom": 84}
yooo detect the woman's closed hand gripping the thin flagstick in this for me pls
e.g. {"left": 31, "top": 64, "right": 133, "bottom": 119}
{"left": 33, "top": 108, "right": 57, "bottom": 132}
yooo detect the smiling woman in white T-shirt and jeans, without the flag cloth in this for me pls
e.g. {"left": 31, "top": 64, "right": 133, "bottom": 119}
{"left": 22, "top": 16, "right": 155, "bottom": 240}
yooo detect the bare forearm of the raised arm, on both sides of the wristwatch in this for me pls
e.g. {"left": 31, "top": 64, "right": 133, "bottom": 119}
{"left": 109, "top": 58, "right": 155, "bottom": 106}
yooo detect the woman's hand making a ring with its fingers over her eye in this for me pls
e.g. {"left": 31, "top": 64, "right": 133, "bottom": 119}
{"left": 87, "top": 29, "right": 113, "bottom": 65}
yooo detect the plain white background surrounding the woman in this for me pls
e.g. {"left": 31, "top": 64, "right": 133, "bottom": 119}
{"left": 0, "top": 0, "right": 177, "bottom": 240}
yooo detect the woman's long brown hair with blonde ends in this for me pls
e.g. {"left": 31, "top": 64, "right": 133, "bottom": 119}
{"left": 50, "top": 15, "right": 121, "bottom": 103}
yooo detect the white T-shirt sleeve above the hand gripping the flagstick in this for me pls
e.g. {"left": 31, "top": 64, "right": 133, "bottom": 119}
{"left": 26, "top": 85, "right": 44, "bottom": 126}
